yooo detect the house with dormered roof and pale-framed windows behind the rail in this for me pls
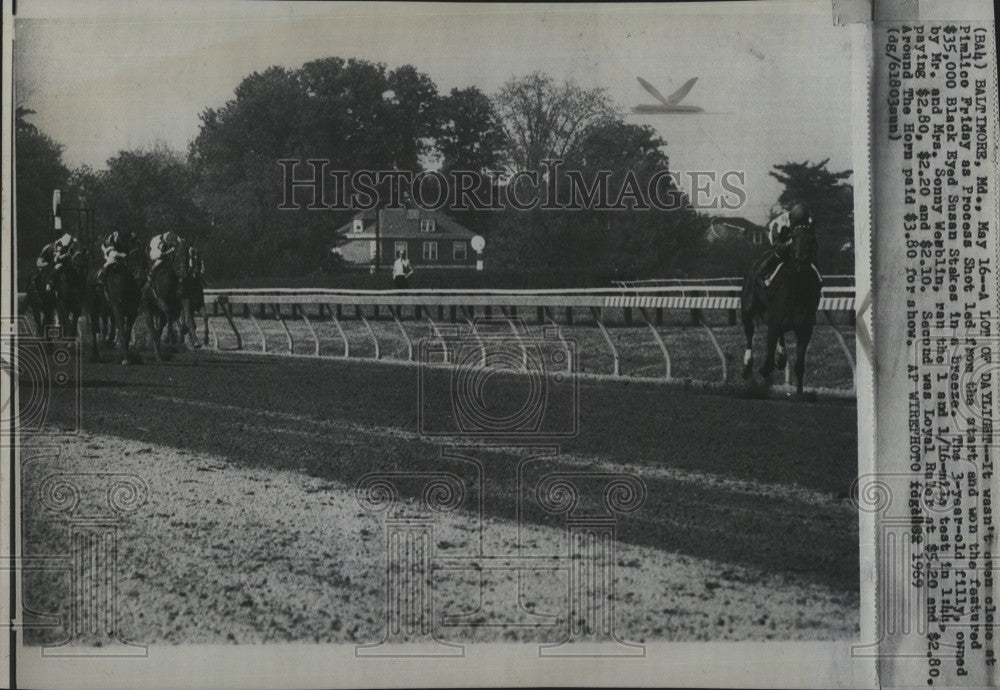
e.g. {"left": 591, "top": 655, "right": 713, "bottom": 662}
{"left": 333, "top": 208, "right": 476, "bottom": 269}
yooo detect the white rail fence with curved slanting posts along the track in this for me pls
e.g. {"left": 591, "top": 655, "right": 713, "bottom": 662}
{"left": 197, "top": 283, "right": 855, "bottom": 383}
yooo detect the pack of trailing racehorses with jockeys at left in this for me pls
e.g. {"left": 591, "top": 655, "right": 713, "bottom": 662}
{"left": 26, "top": 241, "right": 208, "bottom": 365}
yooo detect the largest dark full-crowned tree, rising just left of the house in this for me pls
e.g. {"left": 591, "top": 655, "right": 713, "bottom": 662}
{"left": 190, "top": 57, "right": 440, "bottom": 276}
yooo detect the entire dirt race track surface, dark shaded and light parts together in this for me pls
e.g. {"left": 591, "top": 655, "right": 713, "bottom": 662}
{"left": 22, "top": 351, "right": 859, "bottom": 643}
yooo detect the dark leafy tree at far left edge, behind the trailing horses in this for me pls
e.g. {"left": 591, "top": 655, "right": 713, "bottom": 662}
{"left": 14, "top": 106, "right": 69, "bottom": 280}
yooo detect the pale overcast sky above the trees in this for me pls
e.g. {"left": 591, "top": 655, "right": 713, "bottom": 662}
{"left": 15, "top": 0, "right": 851, "bottom": 222}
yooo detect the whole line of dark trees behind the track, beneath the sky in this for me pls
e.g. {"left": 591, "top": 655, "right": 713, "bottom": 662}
{"left": 16, "top": 57, "right": 853, "bottom": 279}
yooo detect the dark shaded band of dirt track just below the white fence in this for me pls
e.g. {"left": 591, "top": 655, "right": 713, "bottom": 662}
{"left": 41, "top": 352, "right": 859, "bottom": 590}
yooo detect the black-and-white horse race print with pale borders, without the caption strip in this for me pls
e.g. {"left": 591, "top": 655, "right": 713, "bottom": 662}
{"left": 11, "top": 0, "right": 984, "bottom": 687}
